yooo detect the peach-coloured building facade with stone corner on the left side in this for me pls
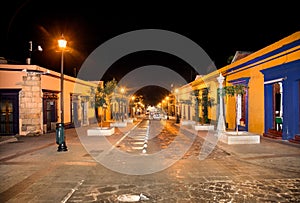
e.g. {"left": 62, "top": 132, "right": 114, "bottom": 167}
{"left": 0, "top": 64, "right": 97, "bottom": 135}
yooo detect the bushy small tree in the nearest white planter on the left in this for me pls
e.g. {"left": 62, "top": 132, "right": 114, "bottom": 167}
{"left": 95, "top": 79, "right": 118, "bottom": 128}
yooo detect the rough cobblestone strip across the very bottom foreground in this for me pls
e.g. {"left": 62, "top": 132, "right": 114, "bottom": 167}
{"left": 68, "top": 179, "right": 300, "bottom": 202}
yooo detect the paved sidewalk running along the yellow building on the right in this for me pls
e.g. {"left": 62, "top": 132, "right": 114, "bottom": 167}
{"left": 181, "top": 126, "right": 300, "bottom": 174}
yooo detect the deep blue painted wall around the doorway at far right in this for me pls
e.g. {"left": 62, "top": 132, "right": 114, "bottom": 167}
{"left": 261, "top": 60, "right": 300, "bottom": 140}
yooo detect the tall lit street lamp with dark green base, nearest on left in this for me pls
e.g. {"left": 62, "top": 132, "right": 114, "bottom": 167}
{"left": 56, "top": 35, "right": 68, "bottom": 152}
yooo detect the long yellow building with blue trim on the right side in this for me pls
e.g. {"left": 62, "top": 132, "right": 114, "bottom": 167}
{"left": 178, "top": 32, "right": 300, "bottom": 140}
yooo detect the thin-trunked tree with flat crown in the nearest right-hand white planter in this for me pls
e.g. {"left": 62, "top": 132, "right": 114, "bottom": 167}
{"left": 218, "top": 84, "right": 249, "bottom": 134}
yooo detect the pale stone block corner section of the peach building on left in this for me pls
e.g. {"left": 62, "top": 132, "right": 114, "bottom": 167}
{"left": 20, "top": 72, "right": 43, "bottom": 135}
